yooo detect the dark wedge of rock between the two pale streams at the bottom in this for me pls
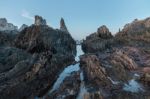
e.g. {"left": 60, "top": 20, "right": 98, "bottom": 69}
{"left": 45, "top": 72, "right": 81, "bottom": 99}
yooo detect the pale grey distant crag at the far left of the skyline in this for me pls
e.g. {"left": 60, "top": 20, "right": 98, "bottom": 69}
{"left": 0, "top": 18, "right": 18, "bottom": 31}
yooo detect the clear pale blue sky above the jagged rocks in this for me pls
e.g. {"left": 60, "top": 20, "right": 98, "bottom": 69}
{"left": 0, "top": 0, "right": 150, "bottom": 40}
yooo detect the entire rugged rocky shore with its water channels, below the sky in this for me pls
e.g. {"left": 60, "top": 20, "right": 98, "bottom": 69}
{"left": 0, "top": 16, "right": 150, "bottom": 99}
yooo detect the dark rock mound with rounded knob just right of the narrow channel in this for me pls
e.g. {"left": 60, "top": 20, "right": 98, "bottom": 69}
{"left": 82, "top": 26, "right": 114, "bottom": 53}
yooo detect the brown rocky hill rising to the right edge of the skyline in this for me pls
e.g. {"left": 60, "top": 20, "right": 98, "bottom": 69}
{"left": 115, "top": 18, "right": 150, "bottom": 47}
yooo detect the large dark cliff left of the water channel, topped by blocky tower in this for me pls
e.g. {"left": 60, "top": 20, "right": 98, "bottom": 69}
{"left": 0, "top": 16, "right": 76, "bottom": 99}
